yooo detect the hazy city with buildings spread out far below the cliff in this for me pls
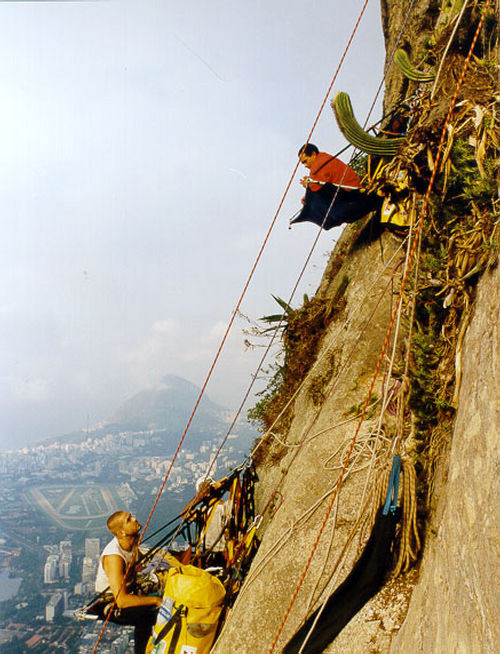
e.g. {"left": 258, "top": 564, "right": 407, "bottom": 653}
{"left": 0, "top": 382, "right": 255, "bottom": 654}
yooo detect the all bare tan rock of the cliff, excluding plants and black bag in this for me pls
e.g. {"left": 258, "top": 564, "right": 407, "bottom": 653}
{"left": 212, "top": 0, "right": 500, "bottom": 654}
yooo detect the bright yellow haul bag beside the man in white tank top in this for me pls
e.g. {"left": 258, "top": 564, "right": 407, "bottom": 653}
{"left": 146, "top": 556, "right": 226, "bottom": 654}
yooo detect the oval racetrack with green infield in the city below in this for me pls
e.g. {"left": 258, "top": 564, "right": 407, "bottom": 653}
{"left": 24, "top": 484, "right": 123, "bottom": 531}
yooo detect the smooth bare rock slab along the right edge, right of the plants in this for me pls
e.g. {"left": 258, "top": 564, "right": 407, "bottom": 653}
{"left": 391, "top": 266, "right": 500, "bottom": 654}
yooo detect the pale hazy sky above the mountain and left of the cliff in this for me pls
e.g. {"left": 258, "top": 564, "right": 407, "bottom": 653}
{"left": 0, "top": 0, "right": 383, "bottom": 449}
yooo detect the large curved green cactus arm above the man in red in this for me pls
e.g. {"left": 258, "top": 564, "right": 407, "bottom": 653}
{"left": 332, "top": 92, "right": 405, "bottom": 157}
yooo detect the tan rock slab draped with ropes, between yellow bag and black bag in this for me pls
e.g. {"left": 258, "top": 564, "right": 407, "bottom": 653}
{"left": 213, "top": 226, "right": 414, "bottom": 654}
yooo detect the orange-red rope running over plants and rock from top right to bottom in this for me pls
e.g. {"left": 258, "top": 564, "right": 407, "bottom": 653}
{"left": 269, "top": 0, "right": 490, "bottom": 654}
